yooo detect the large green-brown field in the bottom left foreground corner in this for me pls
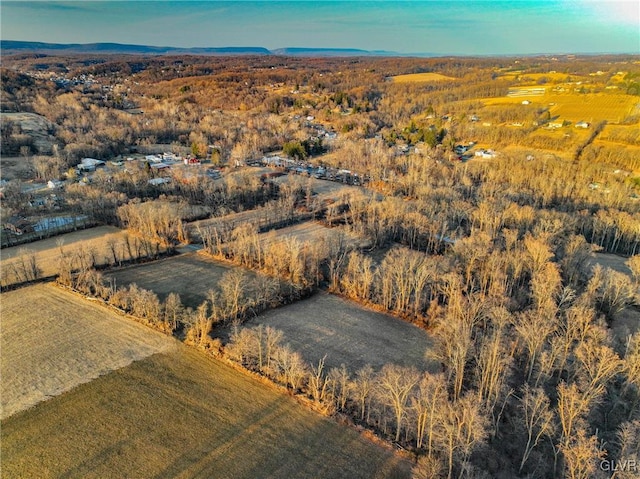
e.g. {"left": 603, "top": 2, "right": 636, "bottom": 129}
{"left": 2, "top": 345, "right": 410, "bottom": 479}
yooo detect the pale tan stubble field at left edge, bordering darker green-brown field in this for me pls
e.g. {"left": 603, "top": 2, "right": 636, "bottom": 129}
{"left": 0, "top": 284, "right": 177, "bottom": 420}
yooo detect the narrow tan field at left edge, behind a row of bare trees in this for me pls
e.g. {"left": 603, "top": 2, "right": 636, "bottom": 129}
{"left": 0, "top": 226, "right": 129, "bottom": 286}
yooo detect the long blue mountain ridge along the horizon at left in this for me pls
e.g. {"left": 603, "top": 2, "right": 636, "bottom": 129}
{"left": 0, "top": 40, "right": 405, "bottom": 57}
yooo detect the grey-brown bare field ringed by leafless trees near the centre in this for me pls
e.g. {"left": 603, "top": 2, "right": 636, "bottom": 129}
{"left": 242, "top": 293, "right": 438, "bottom": 373}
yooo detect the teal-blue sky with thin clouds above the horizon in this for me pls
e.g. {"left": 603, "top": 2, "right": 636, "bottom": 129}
{"left": 0, "top": 0, "right": 640, "bottom": 55}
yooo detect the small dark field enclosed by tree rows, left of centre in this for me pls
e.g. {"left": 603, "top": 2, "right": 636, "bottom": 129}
{"left": 106, "top": 253, "right": 245, "bottom": 308}
